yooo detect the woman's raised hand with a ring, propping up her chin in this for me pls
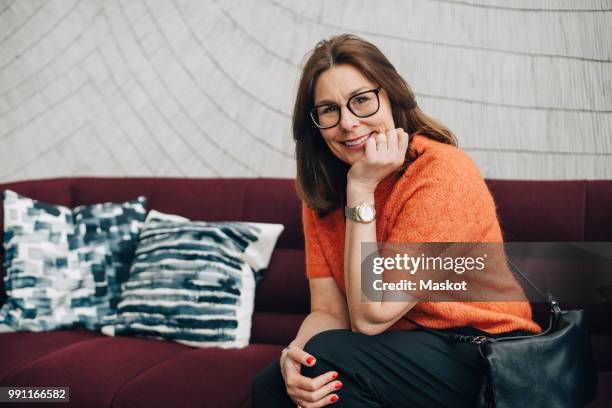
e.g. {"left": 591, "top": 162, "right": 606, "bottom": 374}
{"left": 347, "top": 128, "right": 408, "bottom": 193}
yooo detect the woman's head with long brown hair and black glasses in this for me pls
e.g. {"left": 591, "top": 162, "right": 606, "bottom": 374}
{"left": 293, "top": 34, "right": 457, "bottom": 215}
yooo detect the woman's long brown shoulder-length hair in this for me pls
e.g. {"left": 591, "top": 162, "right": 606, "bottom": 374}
{"left": 293, "top": 34, "right": 457, "bottom": 216}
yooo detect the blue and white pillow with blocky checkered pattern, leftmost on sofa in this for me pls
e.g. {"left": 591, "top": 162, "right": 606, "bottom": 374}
{"left": 0, "top": 190, "right": 146, "bottom": 332}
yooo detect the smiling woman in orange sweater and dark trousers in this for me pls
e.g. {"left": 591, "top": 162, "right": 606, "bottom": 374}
{"left": 253, "top": 35, "right": 540, "bottom": 408}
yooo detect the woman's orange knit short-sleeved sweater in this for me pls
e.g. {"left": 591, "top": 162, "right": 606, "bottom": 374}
{"left": 302, "top": 136, "right": 541, "bottom": 334}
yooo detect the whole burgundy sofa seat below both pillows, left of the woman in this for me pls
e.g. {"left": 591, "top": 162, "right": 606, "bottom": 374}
{"left": 0, "top": 330, "right": 282, "bottom": 408}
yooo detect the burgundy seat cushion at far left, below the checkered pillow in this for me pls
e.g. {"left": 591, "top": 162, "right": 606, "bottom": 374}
{"left": 0, "top": 331, "right": 192, "bottom": 407}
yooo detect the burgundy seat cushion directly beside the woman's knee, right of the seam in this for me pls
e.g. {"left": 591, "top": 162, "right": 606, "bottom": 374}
{"left": 113, "top": 344, "right": 282, "bottom": 408}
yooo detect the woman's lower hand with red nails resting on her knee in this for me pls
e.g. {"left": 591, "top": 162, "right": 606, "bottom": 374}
{"left": 280, "top": 346, "right": 342, "bottom": 408}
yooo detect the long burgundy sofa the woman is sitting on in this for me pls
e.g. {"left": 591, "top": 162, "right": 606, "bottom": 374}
{"left": 0, "top": 178, "right": 612, "bottom": 408}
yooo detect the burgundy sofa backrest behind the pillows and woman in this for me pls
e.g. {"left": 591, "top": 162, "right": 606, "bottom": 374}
{"left": 0, "top": 178, "right": 612, "bottom": 344}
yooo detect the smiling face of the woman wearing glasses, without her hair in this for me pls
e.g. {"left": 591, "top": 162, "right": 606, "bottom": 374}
{"left": 314, "top": 64, "right": 395, "bottom": 165}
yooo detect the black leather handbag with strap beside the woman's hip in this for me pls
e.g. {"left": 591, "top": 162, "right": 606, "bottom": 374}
{"left": 407, "top": 261, "right": 597, "bottom": 408}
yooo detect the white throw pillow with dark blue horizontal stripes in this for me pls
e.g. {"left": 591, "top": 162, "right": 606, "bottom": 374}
{"left": 102, "top": 211, "right": 284, "bottom": 348}
